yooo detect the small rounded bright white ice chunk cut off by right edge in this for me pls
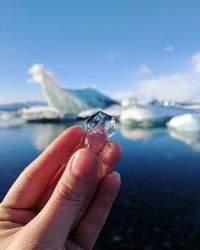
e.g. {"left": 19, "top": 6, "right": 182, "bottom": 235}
{"left": 167, "top": 114, "right": 200, "bottom": 131}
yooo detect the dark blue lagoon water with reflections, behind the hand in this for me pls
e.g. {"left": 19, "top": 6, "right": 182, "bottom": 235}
{"left": 0, "top": 124, "right": 200, "bottom": 250}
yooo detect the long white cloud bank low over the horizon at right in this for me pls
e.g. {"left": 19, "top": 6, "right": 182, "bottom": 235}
{"left": 114, "top": 53, "right": 200, "bottom": 102}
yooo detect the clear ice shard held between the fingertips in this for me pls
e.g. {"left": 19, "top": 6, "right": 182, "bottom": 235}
{"left": 85, "top": 111, "right": 116, "bottom": 155}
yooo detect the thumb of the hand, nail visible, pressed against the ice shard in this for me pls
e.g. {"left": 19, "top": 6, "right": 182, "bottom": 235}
{"left": 27, "top": 149, "right": 97, "bottom": 248}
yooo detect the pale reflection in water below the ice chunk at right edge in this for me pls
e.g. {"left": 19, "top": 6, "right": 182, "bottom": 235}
{"left": 168, "top": 129, "right": 200, "bottom": 152}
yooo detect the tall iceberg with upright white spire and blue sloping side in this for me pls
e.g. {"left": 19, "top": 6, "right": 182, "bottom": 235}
{"left": 29, "top": 64, "right": 118, "bottom": 114}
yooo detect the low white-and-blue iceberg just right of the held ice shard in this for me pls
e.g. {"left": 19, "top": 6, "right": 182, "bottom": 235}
{"left": 120, "top": 105, "right": 192, "bottom": 127}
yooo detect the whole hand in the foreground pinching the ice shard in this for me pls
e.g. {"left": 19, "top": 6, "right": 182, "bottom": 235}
{"left": 0, "top": 126, "right": 121, "bottom": 250}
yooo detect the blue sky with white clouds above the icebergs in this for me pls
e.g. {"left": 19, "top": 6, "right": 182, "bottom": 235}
{"left": 0, "top": 0, "right": 200, "bottom": 102}
